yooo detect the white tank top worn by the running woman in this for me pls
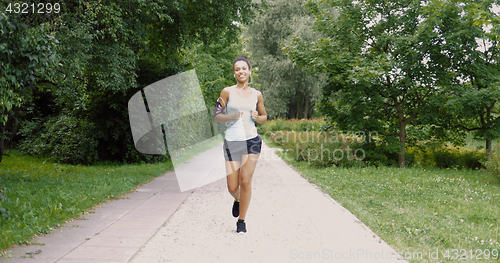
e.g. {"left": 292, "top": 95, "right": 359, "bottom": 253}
{"left": 226, "top": 86, "right": 258, "bottom": 141}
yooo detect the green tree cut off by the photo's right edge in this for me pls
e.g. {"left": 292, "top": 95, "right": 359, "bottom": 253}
{"left": 422, "top": 0, "right": 500, "bottom": 157}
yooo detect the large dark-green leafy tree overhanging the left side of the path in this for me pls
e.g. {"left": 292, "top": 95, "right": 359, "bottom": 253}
{"left": 8, "top": 0, "right": 252, "bottom": 163}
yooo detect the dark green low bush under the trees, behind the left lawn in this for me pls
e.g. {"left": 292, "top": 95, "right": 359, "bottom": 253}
{"left": 17, "top": 112, "right": 168, "bottom": 164}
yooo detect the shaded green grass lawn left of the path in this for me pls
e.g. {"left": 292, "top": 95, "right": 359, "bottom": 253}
{"left": 0, "top": 152, "right": 173, "bottom": 251}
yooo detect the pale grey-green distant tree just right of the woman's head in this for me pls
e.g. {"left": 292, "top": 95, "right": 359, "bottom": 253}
{"left": 245, "top": 0, "right": 324, "bottom": 118}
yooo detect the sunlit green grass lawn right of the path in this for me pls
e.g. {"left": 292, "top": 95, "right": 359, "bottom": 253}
{"left": 268, "top": 139, "right": 500, "bottom": 262}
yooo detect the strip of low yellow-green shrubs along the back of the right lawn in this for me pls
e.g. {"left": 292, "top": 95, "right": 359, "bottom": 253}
{"left": 266, "top": 118, "right": 486, "bottom": 169}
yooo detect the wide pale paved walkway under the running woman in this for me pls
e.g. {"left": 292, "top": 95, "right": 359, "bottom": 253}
{"left": 0, "top": 145, "right": 405, "bottom": 263}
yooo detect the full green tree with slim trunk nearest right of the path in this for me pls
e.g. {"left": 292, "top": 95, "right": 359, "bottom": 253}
{"left": 286, "top": 0, "right": 454, "bottom": 167}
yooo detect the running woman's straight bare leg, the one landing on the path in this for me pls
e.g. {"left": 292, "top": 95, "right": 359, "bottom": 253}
{"left": 239, "top": 153, "right": 260, "bottom": 220}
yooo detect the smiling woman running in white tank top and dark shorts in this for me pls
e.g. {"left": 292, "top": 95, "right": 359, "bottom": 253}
{"left": 214, "top": 56, "right": 267, "bottom": 233}
